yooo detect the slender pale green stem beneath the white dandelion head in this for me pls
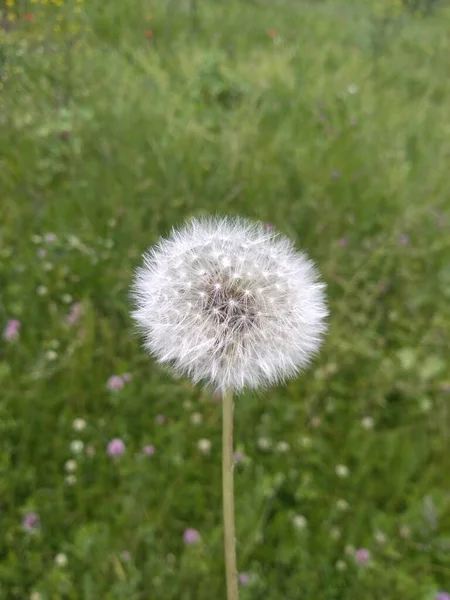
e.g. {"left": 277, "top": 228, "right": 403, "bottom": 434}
{"left": 222, "top": 390, "right": 239, "bottom": 600}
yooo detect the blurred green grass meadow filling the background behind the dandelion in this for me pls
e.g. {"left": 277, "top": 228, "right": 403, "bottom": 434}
{"left": 0, "top": 0, "right": 450, "bottom": 600}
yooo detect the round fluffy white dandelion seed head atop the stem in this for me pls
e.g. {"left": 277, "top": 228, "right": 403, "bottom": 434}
{"left": 132, "top": 217, "right": 328, "bottom": 393}
